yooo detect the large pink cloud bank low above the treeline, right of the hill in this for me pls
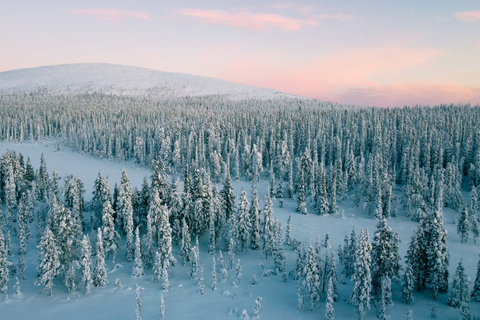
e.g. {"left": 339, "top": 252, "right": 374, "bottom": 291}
{"left": 215, "top": 46, "right": 480, "bottom": 107}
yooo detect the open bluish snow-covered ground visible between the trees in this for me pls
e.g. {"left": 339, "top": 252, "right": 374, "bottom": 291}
{"left": 0, "top": 143, "right": 480, "bottom": 320}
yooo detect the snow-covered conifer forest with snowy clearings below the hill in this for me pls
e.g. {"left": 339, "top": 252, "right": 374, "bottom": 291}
{"left": 0, "top": 90, "right": 480, "bottom": 320}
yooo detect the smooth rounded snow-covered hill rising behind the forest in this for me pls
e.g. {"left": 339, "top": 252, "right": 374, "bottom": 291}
{"left": 0, "top": 63, "right": 294, "bottom": 99}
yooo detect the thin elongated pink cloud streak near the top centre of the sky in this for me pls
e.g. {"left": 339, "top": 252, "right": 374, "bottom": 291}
{"left": 179, "top": 8, "right": 317, "bottom": 31}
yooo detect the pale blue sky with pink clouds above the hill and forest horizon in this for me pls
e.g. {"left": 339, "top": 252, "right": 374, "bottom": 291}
{"left": 0, "top": 0, "right": 480, "bottom": 107}
